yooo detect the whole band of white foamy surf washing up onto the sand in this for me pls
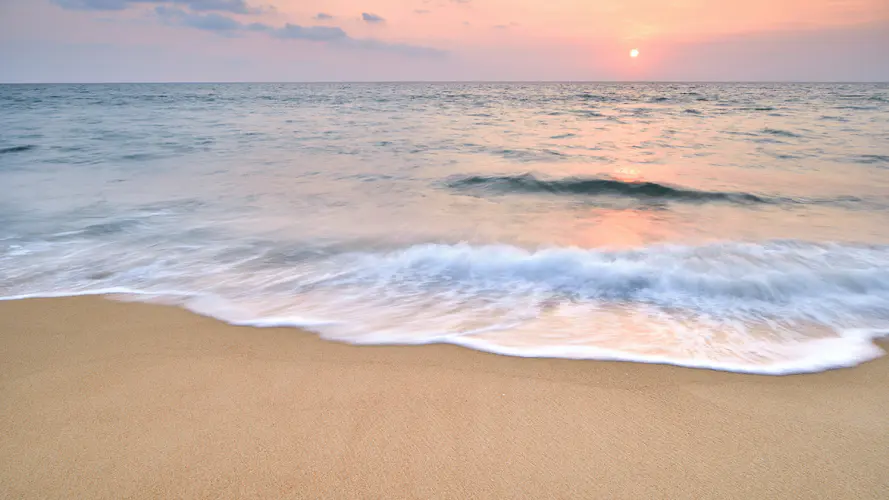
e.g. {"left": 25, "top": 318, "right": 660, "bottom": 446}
{"left": 0, "top": 241, "right": 889, "bottom": 374}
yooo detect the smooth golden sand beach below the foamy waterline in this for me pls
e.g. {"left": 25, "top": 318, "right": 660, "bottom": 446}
{"left": 0, "top": 297, "right": 889, "bottom": 499}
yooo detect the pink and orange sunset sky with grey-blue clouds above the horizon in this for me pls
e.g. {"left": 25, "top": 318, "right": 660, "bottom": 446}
{"left": 0, "top": 0, "right": 889, "bottom": 82}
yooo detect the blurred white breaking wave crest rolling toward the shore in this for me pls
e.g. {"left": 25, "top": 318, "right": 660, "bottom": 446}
{"left": 344, "top": 241, "right": 889, "bottom": 304}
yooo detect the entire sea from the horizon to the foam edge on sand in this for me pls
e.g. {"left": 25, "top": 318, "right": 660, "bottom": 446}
{"left": 0, "top": 83, "right": 889, "bottom": 374}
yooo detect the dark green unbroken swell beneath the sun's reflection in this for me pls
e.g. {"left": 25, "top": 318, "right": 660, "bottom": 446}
{"left": 447, "top": 174, "right": 774, "bottom": 203}
